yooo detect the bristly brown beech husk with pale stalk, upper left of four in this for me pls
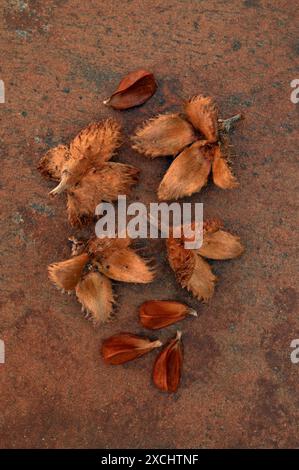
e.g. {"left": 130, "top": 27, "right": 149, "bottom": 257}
{"left": 38, "top": 119, "right": 139, "bottom": 226}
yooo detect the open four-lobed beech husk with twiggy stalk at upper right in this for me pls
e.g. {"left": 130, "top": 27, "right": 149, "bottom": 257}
{"left": 132, "top": 95, "right": 241, "bottom": 200}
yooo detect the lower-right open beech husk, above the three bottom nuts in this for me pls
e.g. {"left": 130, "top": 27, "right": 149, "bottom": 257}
{"left": 166, "top": 221, "right": 244, "bottom": 302}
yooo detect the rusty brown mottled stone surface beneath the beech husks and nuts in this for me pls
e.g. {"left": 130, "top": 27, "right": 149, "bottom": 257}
{"left": 0, "top": 0, "right": 299, "bottom": 448}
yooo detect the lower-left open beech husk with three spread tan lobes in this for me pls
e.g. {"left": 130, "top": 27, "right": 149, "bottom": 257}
{"left": 48, "top": 237, "right": 155, "bottom": 325}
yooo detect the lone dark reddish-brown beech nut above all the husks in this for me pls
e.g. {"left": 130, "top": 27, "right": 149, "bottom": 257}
{"left": 104, "top": 69, "right": 157, "bottom": 109}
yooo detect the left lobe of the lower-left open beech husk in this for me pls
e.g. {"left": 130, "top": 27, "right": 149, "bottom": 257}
{"left": 48, "top": 253, "right": 89, "bottom": 290}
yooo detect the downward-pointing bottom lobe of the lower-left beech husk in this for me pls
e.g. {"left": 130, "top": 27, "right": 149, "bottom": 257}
{"left": 76, "top": 272, "right": 113, "bottom": 325}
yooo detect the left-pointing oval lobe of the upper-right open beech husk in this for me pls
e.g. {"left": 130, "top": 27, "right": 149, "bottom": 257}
{"left": 132, "top": 114, "right": 196, "bottom": 158}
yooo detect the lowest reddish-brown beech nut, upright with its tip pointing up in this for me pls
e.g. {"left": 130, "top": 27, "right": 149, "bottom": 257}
{"left": 153, "top": 331, "right": 183, "bottom": 392}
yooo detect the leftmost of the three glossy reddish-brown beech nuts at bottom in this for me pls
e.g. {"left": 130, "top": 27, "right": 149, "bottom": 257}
{"left": 101, "top": 333, "right": 162, "bottom": 365}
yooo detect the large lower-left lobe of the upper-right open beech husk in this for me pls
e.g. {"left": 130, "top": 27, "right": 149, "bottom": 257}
{"left": 158, "top": 141, "right": 212, "bottom": 200}
